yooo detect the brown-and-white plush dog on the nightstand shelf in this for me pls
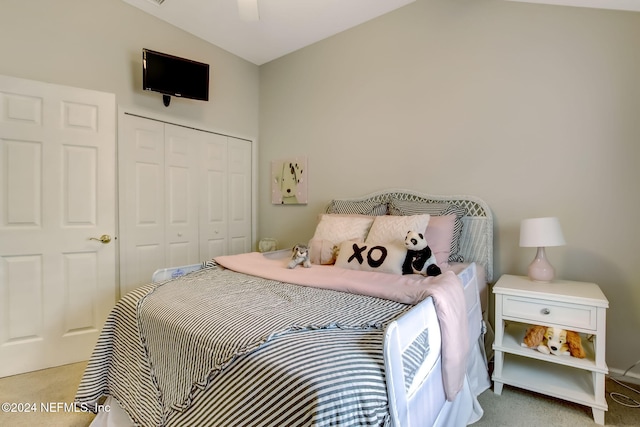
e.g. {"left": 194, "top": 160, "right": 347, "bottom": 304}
{"left": 521, "top": 325, "right": 585, "bottom": 359}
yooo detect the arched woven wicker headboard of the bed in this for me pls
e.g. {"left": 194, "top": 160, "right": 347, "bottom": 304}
{"left": 326, "top": 189, "right": 493, "bottom": 283}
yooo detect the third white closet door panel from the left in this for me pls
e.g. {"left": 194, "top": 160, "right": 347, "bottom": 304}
{"left": 200, "top": 133, "right": 229, "bottom": 261}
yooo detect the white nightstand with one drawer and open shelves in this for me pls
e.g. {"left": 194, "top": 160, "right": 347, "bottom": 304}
{"left": 492, "top": 275, "right": 609, "bottom": 424}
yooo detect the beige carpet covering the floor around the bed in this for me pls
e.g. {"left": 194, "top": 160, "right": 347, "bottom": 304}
{"left": 0, "top": 363, "right": 640, "bottom": 427}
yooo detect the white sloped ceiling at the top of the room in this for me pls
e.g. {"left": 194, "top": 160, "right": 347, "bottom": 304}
{"left": 123, "top": 0, "right": 640, "bottom": 65}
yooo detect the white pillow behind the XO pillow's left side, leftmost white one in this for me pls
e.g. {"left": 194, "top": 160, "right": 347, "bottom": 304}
{"left": 313, "top": 214, "right": 376, "bottom": 246}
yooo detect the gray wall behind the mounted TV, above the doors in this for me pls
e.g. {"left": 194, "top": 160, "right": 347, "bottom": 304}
{"left": 0, "top": 0, "right": 259, "bottom": 138}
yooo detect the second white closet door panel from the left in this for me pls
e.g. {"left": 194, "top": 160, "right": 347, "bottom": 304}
{"left": 164, "top": 124, "right": 199, "bottom": 270}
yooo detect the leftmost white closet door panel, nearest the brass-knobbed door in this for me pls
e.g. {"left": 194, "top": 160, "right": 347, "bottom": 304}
{"left": 118, "top": 114, "right": 167, "bottom": 295}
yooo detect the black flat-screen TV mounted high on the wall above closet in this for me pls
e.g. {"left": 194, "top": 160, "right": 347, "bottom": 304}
{"left": 142, "top": 49, "right": 209, "bottom": 103}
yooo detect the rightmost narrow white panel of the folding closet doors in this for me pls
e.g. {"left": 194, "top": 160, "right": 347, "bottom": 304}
{"left": 227, "top": 137, "right": 252, "bottom": 255}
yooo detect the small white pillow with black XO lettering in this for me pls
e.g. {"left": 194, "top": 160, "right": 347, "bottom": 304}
{"left": 335, "top": 241, "right": 407, "bottom": 274}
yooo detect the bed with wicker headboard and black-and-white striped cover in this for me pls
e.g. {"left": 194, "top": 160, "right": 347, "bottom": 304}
{"left": 75, "top": 189, "right": 493, "bottom": 427}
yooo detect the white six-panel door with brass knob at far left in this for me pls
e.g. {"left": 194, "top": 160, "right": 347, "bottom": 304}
{"left": 0, "top": 76, "right": 116, "bottom": 376}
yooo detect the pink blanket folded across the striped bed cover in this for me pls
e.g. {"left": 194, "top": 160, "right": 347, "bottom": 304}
{"left": 215, "top": 252, "right": 469, "bottom": 401}
